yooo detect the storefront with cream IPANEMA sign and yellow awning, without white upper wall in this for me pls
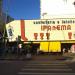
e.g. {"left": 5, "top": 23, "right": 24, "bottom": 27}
{"left": 6, "top": 18, "right": 75, "bottom": 52}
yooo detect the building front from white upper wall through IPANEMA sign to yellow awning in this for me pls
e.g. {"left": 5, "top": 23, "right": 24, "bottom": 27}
{"left": 6, "top": 0, "right": 75, "bottom": 53}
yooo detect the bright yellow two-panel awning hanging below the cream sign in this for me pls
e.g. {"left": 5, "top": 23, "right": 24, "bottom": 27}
{"left": 40, "top": 42, "right": 61, "bottom": 52}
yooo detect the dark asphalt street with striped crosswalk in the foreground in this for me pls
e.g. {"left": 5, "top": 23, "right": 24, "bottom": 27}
{"left": 0, "top": 56, "right": 75, "bottom": 75}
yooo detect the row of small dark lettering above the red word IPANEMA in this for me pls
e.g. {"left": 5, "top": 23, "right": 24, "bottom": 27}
{"left": 33, "top": 19, "right": 75, "bottom": 24}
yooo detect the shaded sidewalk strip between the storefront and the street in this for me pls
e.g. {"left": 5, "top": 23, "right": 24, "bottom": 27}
{"left": 0, "top": 53, "right": 75, "bottom": 62}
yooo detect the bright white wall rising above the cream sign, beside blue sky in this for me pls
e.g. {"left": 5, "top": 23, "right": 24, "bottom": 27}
{"left": 40, "top": 0, "right": 75, "bottom": 19}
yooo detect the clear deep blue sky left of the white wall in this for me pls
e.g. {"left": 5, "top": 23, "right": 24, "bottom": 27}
{"left": 3, "top": 0, "right": 40, "bottom": 20}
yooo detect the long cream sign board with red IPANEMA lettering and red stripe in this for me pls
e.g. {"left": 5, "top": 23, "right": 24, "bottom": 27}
{"left": 6, "top": 18, "right": 75, "bottom": 41}
